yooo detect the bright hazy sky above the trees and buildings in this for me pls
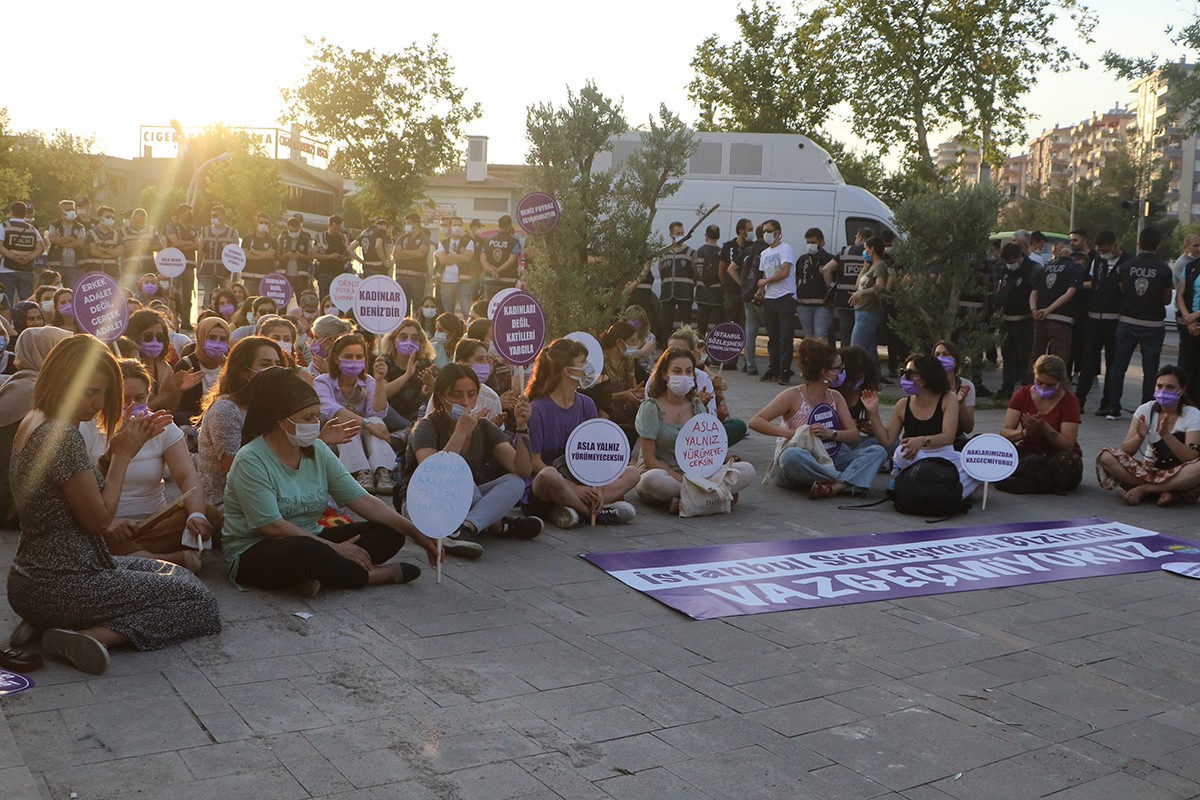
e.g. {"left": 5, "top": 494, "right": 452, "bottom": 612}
{"left": 0, "top": 0, "right": 1198, "bottom": 169}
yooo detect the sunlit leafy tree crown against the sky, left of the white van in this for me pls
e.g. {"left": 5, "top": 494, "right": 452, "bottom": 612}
{"left": 282, "top": 36, "right": 480, "bottom": 219}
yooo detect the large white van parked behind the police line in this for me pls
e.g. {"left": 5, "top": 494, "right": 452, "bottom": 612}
{"left": 595, "top": 131, "right": 895, "bottom": 253}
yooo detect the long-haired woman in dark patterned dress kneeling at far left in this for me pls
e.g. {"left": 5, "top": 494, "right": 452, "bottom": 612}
{"left": 8, "top": 336, "right": 221, "bottom": 674}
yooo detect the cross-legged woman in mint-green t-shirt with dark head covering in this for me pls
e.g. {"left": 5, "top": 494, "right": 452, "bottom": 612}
{"left": 222, "top": 368, "right": 438, "bottom": 597}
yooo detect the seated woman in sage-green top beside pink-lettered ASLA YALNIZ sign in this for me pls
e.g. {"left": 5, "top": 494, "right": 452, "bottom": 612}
{"left": 636, "top": 347, "right": 754, "bottom": 513}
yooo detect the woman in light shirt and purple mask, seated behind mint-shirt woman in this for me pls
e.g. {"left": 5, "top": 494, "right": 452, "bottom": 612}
{"left": 313, "top": 333, "right": 396, "bottom": 494}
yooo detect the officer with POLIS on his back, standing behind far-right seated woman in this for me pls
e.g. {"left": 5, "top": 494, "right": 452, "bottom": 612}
{"left": 1104, "top": 221, "right": 1175, "bottom": 420}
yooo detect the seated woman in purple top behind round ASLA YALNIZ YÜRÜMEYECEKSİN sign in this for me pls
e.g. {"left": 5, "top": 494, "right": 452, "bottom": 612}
{"left": 517, "top": 339, "right": 640, "bottom": 528}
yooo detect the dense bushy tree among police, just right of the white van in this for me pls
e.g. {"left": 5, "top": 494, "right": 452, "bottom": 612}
{"left": 890, "top": 185, "right": 1002, "bottom": 363}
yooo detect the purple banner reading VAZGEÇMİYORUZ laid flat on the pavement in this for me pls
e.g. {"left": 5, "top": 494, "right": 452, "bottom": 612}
{"left": 581, "top": 517, "right": 1200, "bottom": 619}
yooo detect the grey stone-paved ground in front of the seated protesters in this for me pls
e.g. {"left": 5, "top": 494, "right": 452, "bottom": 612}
{"left": 0, "top": 352, "right": 1200, "bottom": 800}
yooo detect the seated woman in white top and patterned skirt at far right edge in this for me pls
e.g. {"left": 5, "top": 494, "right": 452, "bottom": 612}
{"left": 1099, "top": 365, "right": 1200, "bottom": 506}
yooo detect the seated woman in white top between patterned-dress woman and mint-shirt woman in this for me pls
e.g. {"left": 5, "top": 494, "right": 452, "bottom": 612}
{"left": 79, "top": 359, "right": 221, "bottom": 573}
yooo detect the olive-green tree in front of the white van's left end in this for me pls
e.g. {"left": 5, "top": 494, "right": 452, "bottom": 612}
{"left": 526, "top": 82, "right": 697, "bottom": 336}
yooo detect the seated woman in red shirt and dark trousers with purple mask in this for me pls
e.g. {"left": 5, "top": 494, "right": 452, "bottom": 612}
{"left": 996, "top": 355, "right": 1084, "bottom": 494}
